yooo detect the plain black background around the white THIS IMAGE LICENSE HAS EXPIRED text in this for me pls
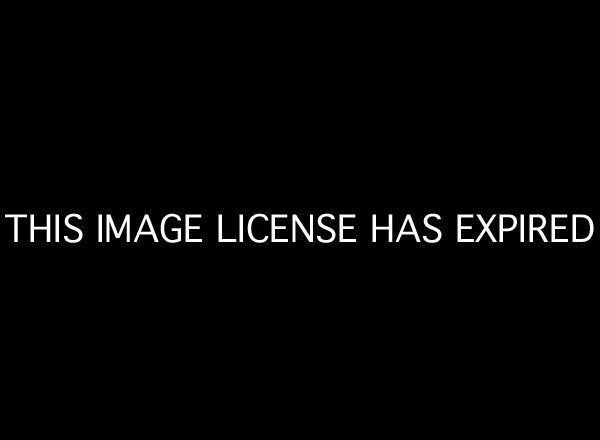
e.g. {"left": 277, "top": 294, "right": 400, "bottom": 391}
{"left": 1, "top": 5, "right": 598, "bottom": 433}
